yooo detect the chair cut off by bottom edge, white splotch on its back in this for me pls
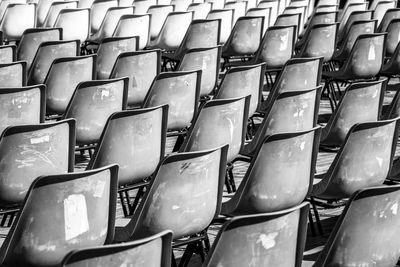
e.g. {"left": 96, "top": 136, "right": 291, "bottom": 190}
{"left": 203, "top": 203, "right": 309, "bottom": 267}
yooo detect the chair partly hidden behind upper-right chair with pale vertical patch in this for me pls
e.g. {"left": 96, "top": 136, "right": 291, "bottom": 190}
{"left": 333, "top": 20, "right": 377, "bottom": 62}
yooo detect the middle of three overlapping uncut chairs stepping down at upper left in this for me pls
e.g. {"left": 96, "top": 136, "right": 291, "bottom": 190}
{"left": 28, "top": 40, "right": 79, "bottom": 85}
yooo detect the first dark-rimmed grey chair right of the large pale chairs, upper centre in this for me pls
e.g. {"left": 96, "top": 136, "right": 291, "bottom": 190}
{"left": 163, "top": 19, "right": 221, "bottom": 65}
